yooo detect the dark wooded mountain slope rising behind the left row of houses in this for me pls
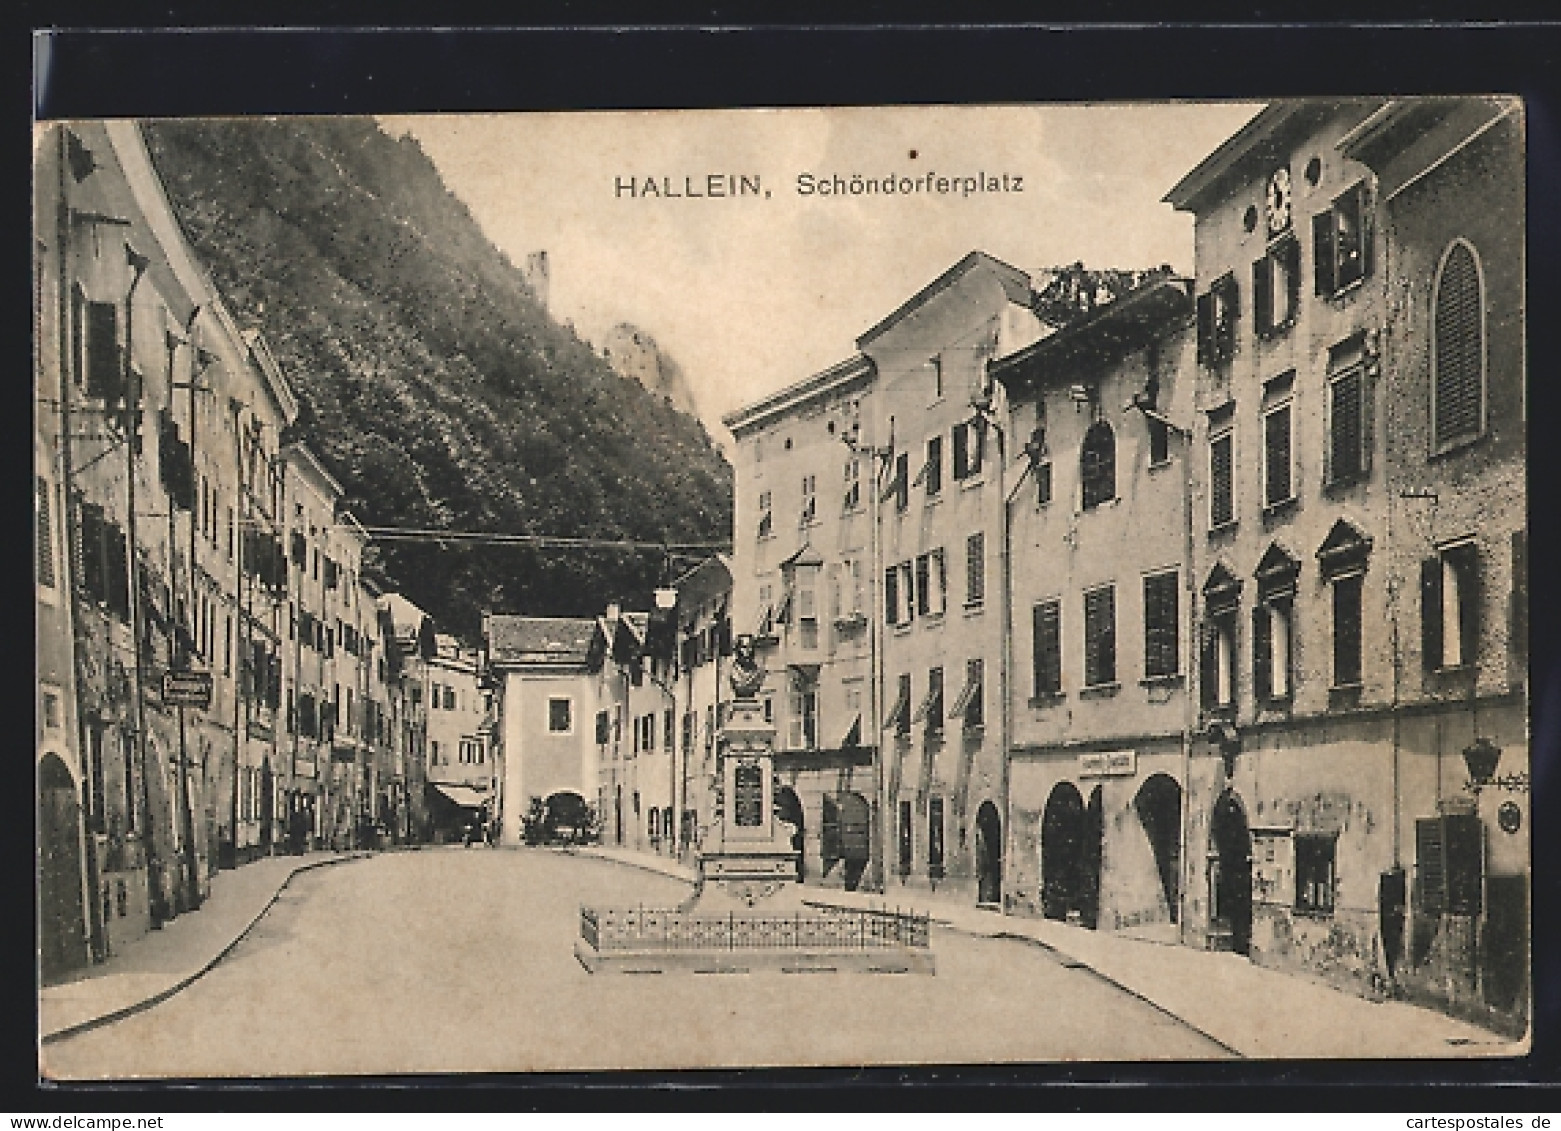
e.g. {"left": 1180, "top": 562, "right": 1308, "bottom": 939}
{"left": 145, "top": 119, "right": 732, "bottom": 636}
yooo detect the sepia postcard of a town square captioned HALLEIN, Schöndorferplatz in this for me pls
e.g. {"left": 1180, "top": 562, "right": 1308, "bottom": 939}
{"left": 31, "top": 94, "right": 1534, "bottom": 1083}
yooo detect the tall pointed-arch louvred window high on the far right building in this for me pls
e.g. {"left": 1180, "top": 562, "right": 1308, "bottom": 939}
{"left": 1431, "top": 240, "right": 1485, "bottom": 449}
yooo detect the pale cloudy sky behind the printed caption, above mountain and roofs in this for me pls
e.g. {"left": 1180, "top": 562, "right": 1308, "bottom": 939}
{"left": 382, "top": 103, "right": 1260, "bottom": 449}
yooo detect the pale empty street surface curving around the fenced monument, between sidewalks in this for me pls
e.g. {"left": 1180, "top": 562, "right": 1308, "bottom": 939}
{"left": 44, "top": 849, "right": 1225, "bottom": 1078}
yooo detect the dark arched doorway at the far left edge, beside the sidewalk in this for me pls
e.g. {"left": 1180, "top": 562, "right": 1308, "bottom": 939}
{"left": 37, "top": 753, "right": 87, "bottom": 981}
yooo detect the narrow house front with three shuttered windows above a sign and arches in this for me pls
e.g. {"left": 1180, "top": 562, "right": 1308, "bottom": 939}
{"left": 991, "top": 278, "right": 1196, "bottom": 939}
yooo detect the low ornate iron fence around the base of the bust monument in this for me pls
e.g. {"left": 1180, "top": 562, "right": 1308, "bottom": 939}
{"left": 581, "top": 906, "right": 930, "bottom": 953}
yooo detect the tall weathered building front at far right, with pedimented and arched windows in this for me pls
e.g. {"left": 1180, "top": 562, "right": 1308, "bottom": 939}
{"left": 1166, "top": 100, "right": 1528, "bottom": 1014}
